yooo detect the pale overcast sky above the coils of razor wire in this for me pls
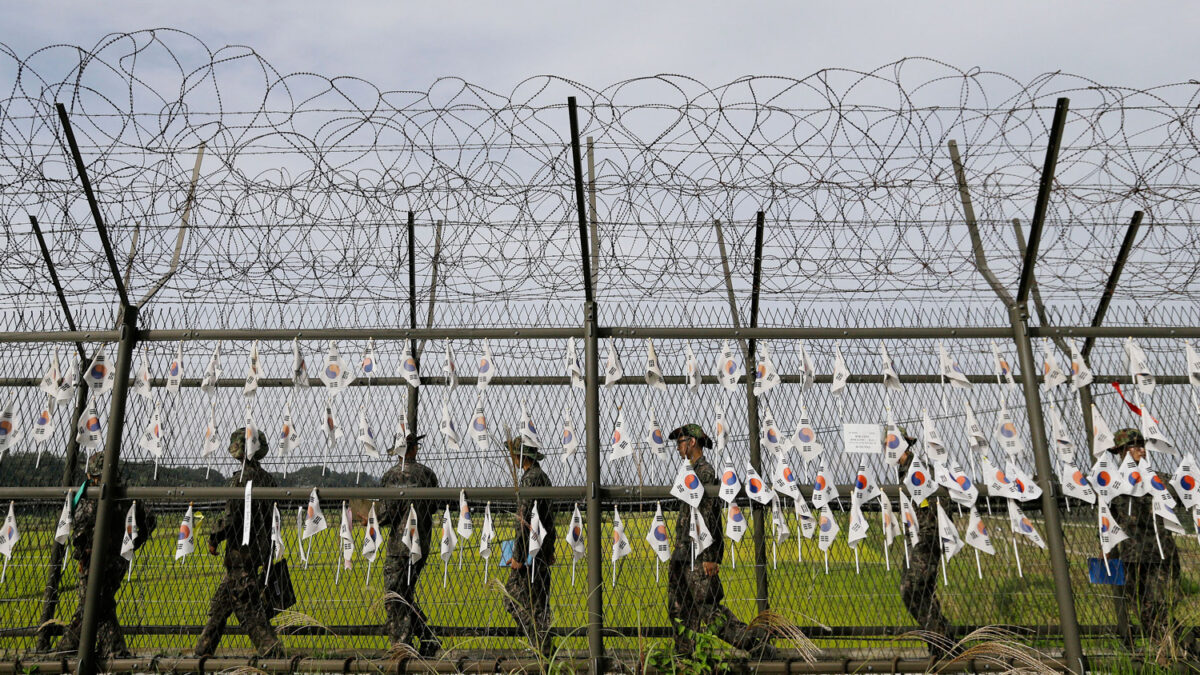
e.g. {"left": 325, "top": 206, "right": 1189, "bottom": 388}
{"left": 0, "top": 0, "right": 1200, "bottom": 91}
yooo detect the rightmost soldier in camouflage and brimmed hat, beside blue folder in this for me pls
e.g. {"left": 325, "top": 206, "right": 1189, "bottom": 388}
{"left": 1109, "top": 429, "right": 1195, "bottom": 653}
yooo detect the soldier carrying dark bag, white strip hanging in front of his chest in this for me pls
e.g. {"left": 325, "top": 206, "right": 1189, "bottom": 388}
{"left": 196, "top": 428, "right": 283, "bottom": 657}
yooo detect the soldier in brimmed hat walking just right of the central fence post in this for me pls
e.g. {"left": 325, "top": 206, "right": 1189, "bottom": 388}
{"left": 667, "top": 424, "right": 779, "bottom": 661}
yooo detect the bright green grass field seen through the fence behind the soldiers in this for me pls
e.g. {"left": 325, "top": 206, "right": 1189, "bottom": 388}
{"left": 0, "top": 506, "right": 1200, "bottom": 656}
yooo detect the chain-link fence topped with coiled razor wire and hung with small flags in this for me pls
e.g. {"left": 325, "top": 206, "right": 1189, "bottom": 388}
{"left": 0, "top": 31, "right": 1200, "bottom": 673}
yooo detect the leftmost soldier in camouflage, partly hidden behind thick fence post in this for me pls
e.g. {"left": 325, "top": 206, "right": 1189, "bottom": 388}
{"left": 56, "top": 452, "right": 157, "bottom": 658}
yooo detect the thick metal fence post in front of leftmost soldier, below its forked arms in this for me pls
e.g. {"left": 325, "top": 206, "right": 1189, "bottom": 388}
{"left": 77, "top": 306, "right": 138, "bottom": 675}
